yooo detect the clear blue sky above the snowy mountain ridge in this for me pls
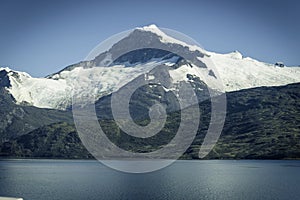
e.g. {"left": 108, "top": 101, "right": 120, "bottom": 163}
{"left": 0, "top": 0, "right": 300, "bottom": 76}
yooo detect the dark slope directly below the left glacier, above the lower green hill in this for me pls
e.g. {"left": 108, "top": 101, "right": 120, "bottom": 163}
{"left": 0, "top": 87, "right": 73, "bottom": 142}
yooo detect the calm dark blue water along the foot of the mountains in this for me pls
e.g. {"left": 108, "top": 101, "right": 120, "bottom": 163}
{"left": 0, "top": 160, "right": 300, "bottom": 200}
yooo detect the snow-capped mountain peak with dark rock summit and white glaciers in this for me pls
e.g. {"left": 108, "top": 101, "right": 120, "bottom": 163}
{"left": 0, "top": 25, "right": 300, "bottom": 109}
